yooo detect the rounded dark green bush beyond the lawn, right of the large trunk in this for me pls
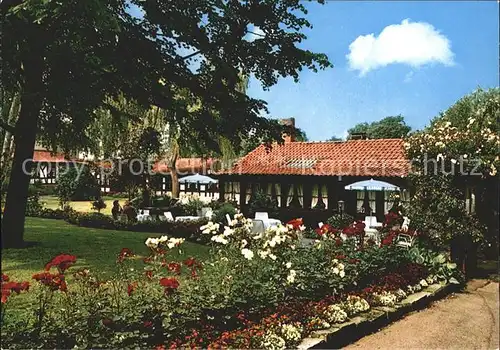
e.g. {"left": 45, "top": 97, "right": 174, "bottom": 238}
{"left": 56, "top": 166, "right": 100, "bottom": 207}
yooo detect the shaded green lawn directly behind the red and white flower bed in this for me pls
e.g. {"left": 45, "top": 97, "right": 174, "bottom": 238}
{"left": 2, "top": 218, "right": 208, "bottom": 281}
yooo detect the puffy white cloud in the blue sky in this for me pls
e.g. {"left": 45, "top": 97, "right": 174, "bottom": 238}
{"left": 346, "top": 19, "right": 454, "bottom": 76}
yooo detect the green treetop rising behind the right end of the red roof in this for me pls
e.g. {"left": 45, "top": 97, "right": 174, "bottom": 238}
{"left": 347, "top": 115, "right": 411, "bottom": 139}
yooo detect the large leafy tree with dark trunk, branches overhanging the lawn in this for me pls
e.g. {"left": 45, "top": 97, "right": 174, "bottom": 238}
{"left": 0, "top": 0, "right": 331, "bottom": 247}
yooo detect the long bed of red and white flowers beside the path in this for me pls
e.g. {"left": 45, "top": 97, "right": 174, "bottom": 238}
{"left": 2, "top": 214, "right": 459, "bottom": 349}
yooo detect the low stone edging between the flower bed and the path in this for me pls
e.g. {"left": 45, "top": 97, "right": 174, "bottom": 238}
{"left": 297, "top": 283, "right": 460, "bottom": 350}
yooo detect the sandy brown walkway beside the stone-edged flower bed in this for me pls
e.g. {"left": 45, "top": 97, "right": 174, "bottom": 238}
{"left": 346, "top": 280, "right": 500, "bottom": 350}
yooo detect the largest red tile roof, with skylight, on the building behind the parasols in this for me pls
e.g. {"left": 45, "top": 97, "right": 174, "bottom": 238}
{"left": 220, "top": 139, "right": 410, "bottom": 176}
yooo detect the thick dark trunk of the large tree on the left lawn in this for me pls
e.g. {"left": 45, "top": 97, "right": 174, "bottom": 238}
{"left": 1, "top": 56, "right": 43, "bottom": 248}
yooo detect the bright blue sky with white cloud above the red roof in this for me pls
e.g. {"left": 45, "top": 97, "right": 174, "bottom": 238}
{"left": 248, "top": 1, "right": 499, "bottom": 140}
